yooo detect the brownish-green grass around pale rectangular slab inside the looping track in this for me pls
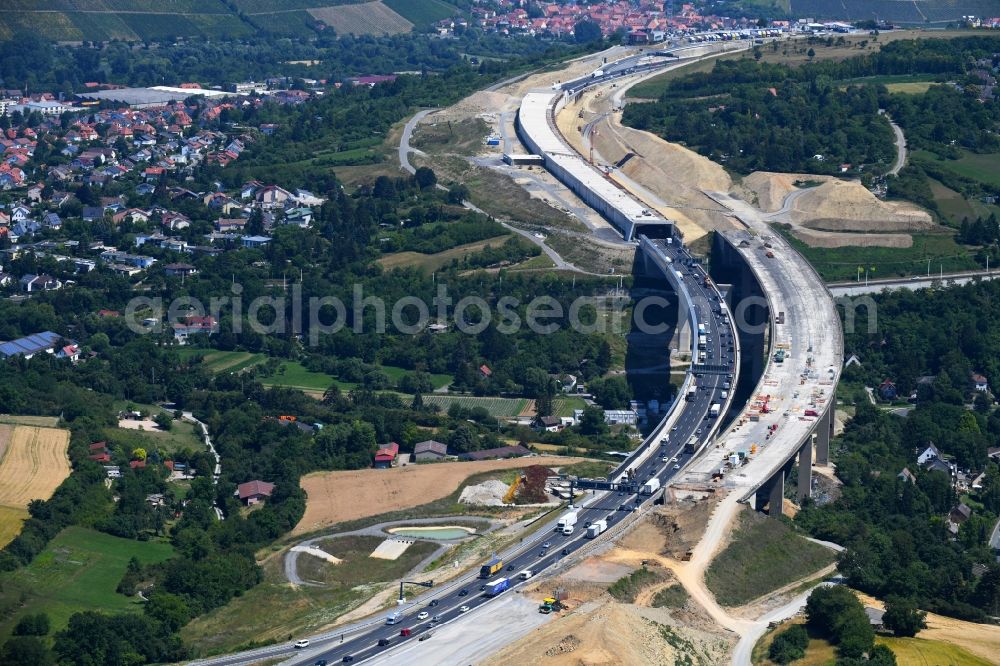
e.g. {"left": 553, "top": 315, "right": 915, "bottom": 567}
{"left": 298, "top": 536, "right": 440, "bottom": 587}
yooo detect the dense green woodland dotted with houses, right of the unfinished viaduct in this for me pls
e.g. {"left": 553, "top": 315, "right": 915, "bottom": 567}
{"left": 795, "top": 282, "right": 1000, "bottom": 621}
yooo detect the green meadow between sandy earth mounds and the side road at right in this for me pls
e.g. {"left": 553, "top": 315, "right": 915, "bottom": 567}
{"left": 775, "top": 226, "right": 979, "bottom": 282}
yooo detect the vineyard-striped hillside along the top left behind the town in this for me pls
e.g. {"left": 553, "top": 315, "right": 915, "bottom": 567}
{"left": 0, "top": 0, "right": 457, "bottom": 41}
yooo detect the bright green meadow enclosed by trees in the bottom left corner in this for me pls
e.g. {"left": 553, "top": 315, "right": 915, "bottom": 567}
{"left": 0, "top": 526, "right": 174, "bottom": 636}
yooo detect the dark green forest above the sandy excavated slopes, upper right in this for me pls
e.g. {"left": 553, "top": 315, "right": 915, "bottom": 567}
{"left": 623, "top": 37, "right": 1000, "bottom": 176}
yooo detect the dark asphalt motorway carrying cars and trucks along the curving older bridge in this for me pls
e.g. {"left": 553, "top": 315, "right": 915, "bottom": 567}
{"left": 282, "top": 241, "right": 735, "bottom": 664}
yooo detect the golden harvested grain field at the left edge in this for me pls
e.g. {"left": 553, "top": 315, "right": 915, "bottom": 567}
{"left": 0, "top": 425, "right": 70, "bottom": 546}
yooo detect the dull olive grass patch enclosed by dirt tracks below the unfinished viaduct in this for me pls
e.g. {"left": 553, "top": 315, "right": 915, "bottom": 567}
{"left": 705, "top": 510, "right": 834, "bottom": 606}
